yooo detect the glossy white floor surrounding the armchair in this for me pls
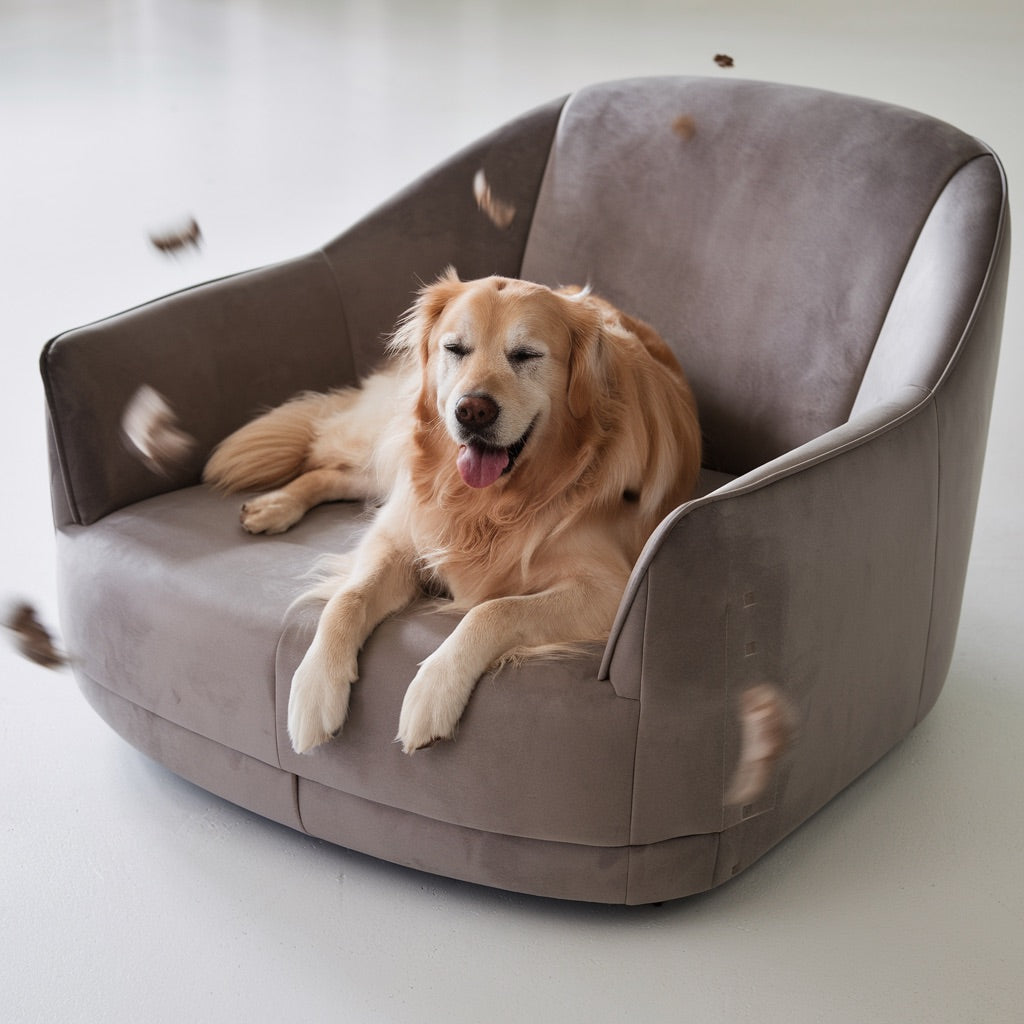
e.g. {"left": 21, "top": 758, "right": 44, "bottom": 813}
{"left": 0, "top": 0, "right": 1024, "bottom": 1024}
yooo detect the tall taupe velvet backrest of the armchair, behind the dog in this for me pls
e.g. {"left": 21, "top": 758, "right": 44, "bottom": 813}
{"left": 521, "top": 78, "right": 1002, "bottom": 473}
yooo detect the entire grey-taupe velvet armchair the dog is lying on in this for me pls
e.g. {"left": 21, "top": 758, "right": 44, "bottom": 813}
{"left": 42, "top": 78, "right": 1010, "bottom": 903}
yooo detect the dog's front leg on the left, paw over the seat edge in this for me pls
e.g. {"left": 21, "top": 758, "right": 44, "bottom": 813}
{"left": 288, "top": 520, "right": 417, "bottom": 754}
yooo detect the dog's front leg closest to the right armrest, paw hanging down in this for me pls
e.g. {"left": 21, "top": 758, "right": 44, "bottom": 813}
{"left": 396, "top": 582, "right": 622, "bottom": 754}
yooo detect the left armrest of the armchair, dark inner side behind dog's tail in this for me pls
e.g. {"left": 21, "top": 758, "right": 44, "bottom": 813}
{"left": 40, "top": 254, "right": 353, "bottom": 524}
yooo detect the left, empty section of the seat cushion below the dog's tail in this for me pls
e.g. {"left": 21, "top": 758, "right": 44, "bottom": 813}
{"left": 58, "top": 487, "right": 360, "bottom": 765}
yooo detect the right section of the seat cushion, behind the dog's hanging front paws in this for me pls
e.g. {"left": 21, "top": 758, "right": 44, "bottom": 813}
{"left": 278, "top": 605, "right": 640, "bottom": 847}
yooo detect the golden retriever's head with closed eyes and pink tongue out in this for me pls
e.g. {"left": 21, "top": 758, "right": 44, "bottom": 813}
{"left": 395, "top": 270, "right": 603, "bottom": 488}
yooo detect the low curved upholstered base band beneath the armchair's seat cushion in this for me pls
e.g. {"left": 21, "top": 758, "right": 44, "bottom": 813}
{"left": 76, "top": 672, "right": 733, "bottom": 905}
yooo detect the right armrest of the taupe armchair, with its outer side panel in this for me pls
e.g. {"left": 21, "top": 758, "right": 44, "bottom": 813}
{"left": 603, "top": 388, "right": 939, "bottom": 843}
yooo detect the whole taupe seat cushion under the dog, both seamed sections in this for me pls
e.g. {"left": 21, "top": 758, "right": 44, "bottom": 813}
{"left": 58, "top": 487, "right": 679, "bottom": 846}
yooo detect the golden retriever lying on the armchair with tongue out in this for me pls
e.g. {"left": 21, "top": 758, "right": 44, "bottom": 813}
{"left": 204, "top": 270, "right": 700, "bottom": 754}
